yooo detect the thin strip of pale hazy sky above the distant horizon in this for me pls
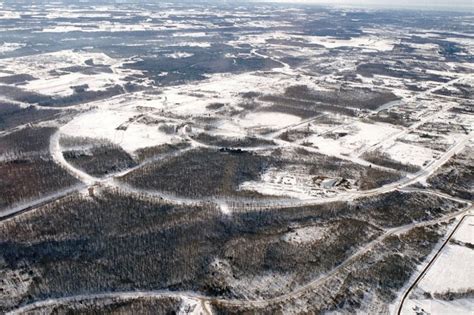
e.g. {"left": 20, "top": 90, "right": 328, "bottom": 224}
{"left": 258, "top": 0, "right": 474, "bottom": 11}
